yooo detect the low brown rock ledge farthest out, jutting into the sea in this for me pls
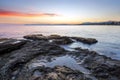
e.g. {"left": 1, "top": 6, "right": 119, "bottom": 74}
{"left": 24, "top": 34, "right": 98, "bottom": 44}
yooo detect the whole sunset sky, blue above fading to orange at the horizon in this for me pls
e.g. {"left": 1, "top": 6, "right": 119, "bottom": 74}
{"left": 0, "top": 0, "right": 120, "bottom": 24}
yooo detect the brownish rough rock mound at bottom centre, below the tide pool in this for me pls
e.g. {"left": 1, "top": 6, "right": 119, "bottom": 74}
{"left": 18, "top": 66, "right": 91, "bottom": 80}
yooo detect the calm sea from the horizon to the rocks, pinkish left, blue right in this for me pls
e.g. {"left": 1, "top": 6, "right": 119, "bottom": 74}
{"left": 0, "top": 24, "right": 120, "bottom": 60}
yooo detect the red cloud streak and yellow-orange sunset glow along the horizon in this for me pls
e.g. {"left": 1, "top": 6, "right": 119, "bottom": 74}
{"left": 0, "top": 10, "right": 120, "bottom": 24}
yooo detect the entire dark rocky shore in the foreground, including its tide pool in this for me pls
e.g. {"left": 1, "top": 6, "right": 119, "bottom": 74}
{"left": 0, "top": 34, "right": 120, "bottom": 80}
